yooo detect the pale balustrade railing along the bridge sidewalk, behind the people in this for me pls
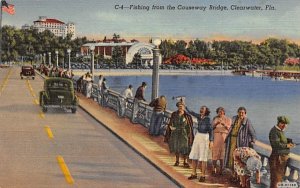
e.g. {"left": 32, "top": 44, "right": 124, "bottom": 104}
{"left": 78, "top": 81, "right": 300, "bottom": 187}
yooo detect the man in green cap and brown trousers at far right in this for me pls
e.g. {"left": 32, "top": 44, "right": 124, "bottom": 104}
{"left": 269, "top": 116, "right": 295, "bottom": 188}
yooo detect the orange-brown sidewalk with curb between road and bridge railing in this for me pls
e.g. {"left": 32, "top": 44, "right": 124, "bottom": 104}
{"left": 77, "top": 94, "right": 233, "bottom": 188}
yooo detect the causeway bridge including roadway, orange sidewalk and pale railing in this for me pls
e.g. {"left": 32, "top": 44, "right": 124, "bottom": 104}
{"left": 0, "top": 67, "right": 300, "bottom": 188}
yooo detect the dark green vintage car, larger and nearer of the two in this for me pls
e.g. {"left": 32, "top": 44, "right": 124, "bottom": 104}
{"left": 40, "top": 77, "right": 78, "bottom": 113}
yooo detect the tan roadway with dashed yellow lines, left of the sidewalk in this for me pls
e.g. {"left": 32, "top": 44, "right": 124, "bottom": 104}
{"left": 0, "top": 67, "right": 177, "bottom": 188}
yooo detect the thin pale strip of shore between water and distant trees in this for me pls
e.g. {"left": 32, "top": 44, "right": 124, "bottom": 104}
{"left": 73, "top": 69, "right": 233, "bottom": 76}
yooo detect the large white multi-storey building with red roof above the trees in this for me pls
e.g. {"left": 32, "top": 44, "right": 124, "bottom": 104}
{"left": 29, "top": 16, "right": 76, "bottom": 39}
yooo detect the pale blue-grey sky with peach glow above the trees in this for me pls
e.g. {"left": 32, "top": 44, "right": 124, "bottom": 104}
{"left": 2, "top": 0, "right": 300, "bottom": 43}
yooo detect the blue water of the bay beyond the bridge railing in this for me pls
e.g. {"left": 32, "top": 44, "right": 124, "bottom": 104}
{"left": 95, "top": 75, "right": 300, "bottom": 154}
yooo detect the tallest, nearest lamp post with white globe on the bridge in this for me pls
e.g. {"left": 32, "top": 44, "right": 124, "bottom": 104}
{"left": 151, "top": 38, "right": 161, "bottom": 100}
